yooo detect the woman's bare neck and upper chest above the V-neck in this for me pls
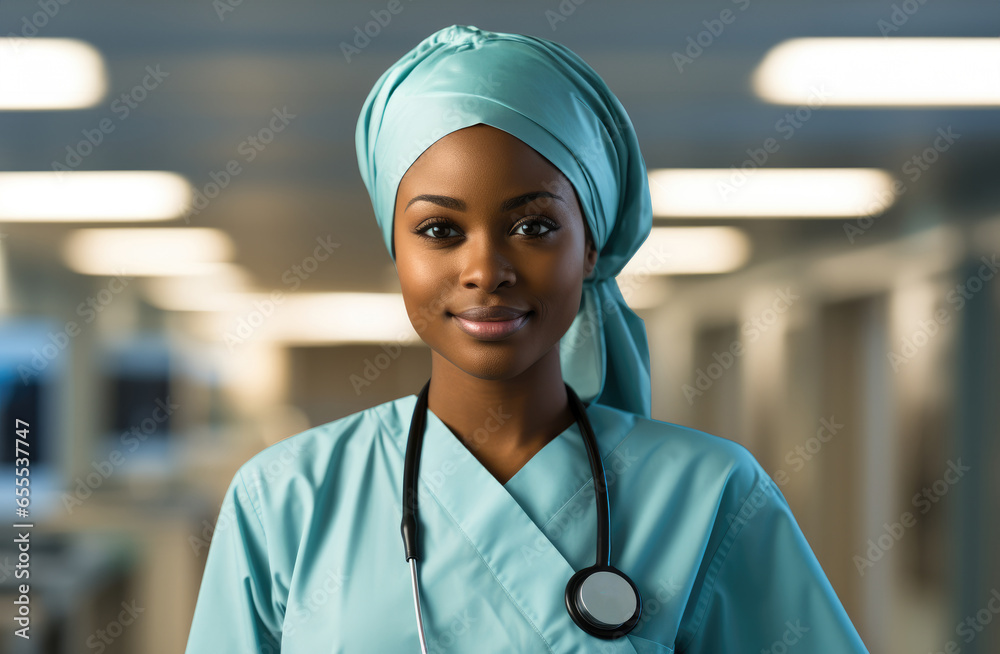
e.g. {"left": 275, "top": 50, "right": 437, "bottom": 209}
{"left": 427, "top": 347, "right": 574, "bottom": 483}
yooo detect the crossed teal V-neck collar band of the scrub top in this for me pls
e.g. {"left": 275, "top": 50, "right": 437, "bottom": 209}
{"left": 386, "top": 395, "right": 635, "bottom": 654}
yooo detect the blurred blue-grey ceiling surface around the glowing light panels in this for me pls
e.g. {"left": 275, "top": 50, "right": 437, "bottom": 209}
{"left": 0, "top": 0, "right": 1000, "bottom": 291}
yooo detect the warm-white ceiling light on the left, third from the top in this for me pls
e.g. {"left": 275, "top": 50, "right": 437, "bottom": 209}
{"left": 63, "top": 227, "right": 234, "bottom": 277}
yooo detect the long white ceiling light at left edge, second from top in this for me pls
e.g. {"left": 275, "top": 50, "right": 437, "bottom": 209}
{"left": 0, "top": 170, "right": 191, "bottom": 222}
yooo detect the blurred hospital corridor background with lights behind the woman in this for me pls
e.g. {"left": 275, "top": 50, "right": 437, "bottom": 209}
{"left": 0, "top": 0, "right": 1000, "bottom": 654}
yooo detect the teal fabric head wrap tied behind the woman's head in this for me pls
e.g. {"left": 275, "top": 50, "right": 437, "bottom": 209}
{"left": 355, "top": 25, "right": 652, "bottom": 417}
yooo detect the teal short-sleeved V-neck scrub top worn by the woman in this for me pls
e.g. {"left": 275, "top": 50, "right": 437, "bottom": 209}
{"left": 186, "top": 395, "right": 867, "bottom": 654}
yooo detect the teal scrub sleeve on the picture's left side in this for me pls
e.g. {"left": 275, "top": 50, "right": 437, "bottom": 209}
{"left": 185, "top": 470, "right": 283, "bottom": 654}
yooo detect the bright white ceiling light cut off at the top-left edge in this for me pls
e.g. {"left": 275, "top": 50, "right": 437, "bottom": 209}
{"left": 0, "top": 37, "right": 108, "bottom": 111}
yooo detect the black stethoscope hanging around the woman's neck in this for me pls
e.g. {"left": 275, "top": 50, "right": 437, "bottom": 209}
{"left": 400, "top": 380, "right": 642, "bottom": 654}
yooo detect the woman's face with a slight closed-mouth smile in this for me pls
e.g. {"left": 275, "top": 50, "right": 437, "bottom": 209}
{"left": 393, "top": 124, "right": 597, "bottom": 379}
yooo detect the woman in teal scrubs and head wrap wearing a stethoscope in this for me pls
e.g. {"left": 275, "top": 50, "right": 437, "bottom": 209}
{"left": 187, "top": 25, "right": 866, "bottom": 654}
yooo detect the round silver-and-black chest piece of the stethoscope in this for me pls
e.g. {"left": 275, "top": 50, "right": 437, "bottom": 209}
{"left": 566, "top": 565, "right": 642, "bottom": 639}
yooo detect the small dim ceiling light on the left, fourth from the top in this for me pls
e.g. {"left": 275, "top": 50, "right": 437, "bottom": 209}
{"left": 142, "top": 263, "right": 252, "bottom": 311}
